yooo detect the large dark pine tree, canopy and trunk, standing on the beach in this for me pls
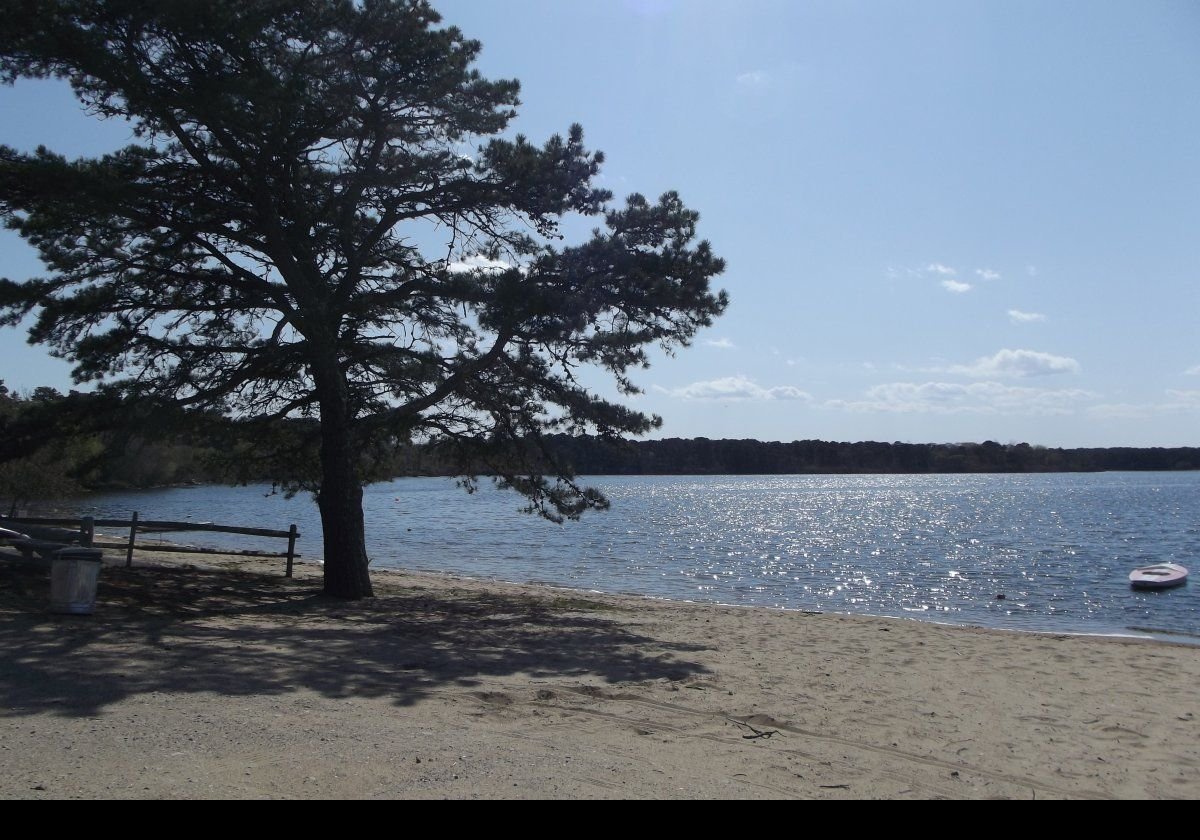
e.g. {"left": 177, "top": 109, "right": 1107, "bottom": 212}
{"left": 0, "top": 0, "right": 726, "bottom": 598}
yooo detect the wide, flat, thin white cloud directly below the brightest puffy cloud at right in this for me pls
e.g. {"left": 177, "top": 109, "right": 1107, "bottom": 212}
{"left": 826, "top": 382, "right": 1097, "bottom": 415}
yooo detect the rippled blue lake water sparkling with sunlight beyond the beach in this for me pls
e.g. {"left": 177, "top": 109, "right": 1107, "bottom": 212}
{"left": 80, "top": 473, "right": 1200, "bottom": 640}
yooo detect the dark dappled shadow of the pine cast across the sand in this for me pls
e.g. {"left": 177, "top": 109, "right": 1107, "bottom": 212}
{"left": 0, "top": 562, "right": 707, "bottom": 718}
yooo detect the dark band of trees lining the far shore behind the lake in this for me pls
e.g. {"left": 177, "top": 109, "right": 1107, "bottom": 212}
{"left": 0, "top": 382, "right": 1200, "bottom": 512}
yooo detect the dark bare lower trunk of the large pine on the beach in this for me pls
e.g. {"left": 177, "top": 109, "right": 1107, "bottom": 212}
{"left": 317, "top": 374, "right": 374, "bottom": 599}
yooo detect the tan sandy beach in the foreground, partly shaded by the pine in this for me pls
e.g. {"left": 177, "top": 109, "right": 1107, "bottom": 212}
{"left": 0, "top": 552, "right": 1200, "bottom": 799}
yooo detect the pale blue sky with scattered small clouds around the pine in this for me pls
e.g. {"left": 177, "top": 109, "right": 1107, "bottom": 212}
{"left": 0, "top": 0, "right": 1200, "bottom": 446}
